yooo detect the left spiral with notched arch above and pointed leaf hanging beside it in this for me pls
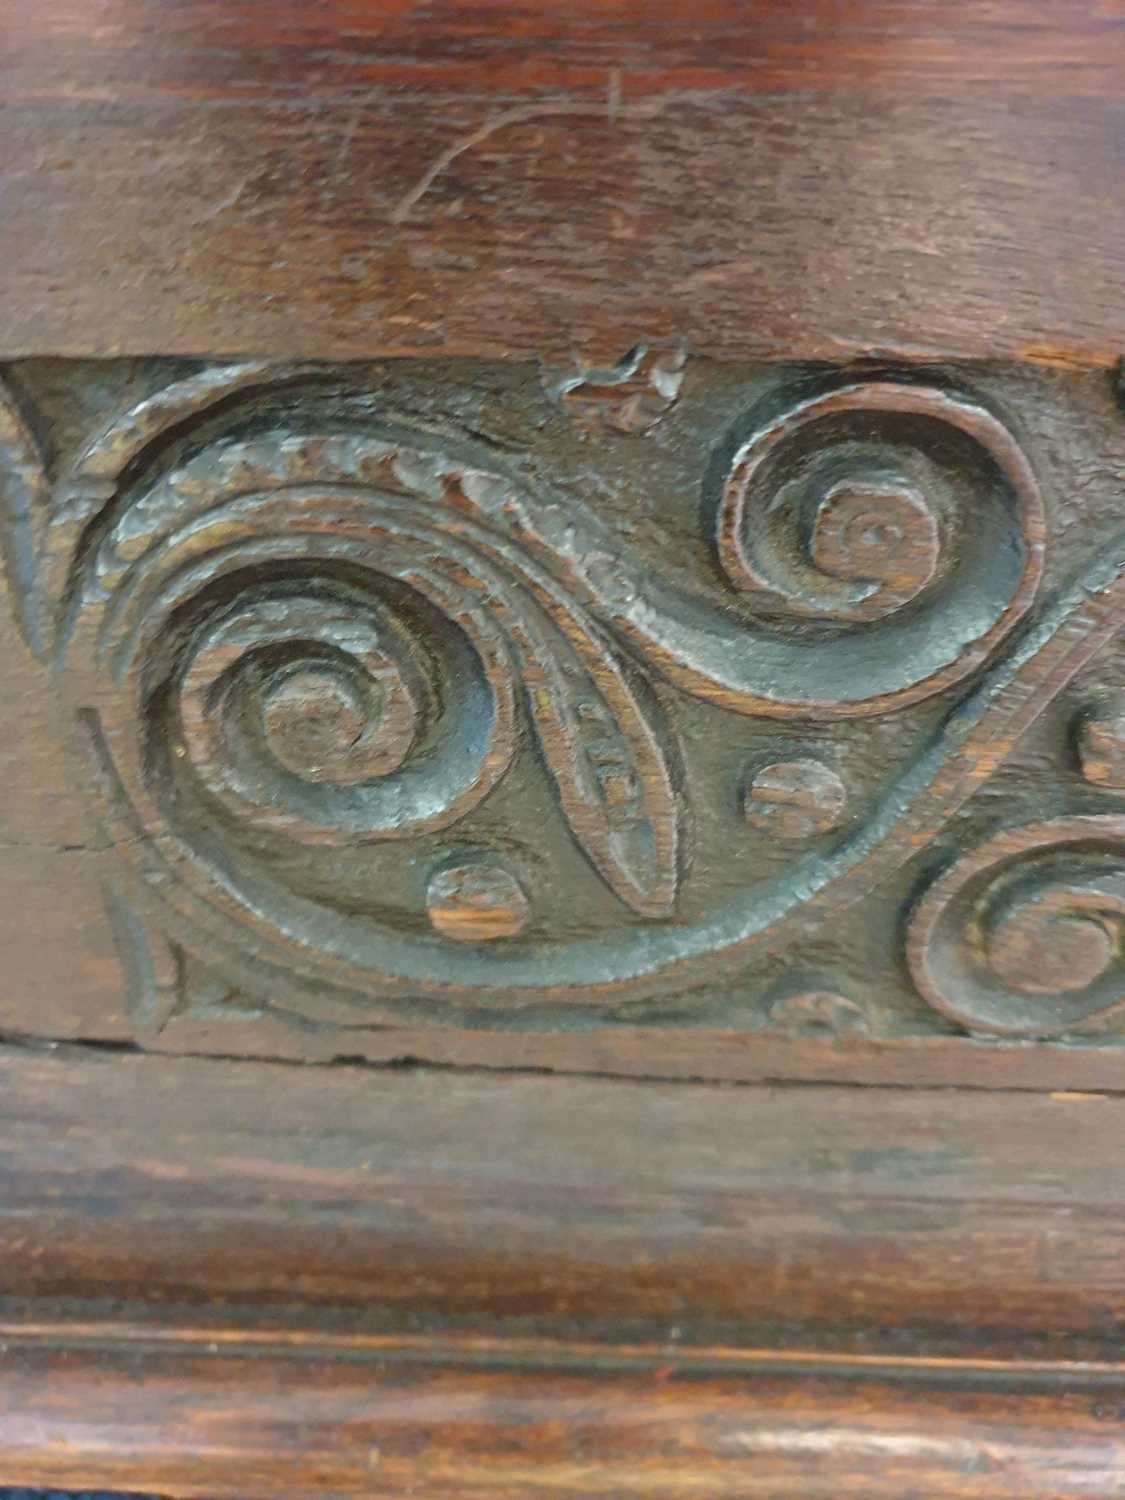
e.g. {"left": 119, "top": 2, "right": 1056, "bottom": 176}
{"left": 69, "top": 420, "right": 687, "bottom": 960}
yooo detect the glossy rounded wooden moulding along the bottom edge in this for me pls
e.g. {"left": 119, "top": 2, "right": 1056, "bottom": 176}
{"left": 0, "top": 1329, "right": 1125, "bottom": 1500}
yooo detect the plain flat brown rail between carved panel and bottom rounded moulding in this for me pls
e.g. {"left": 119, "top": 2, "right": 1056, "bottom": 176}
{"left": 0, "top": 1049, "right": 1125, "bottom": 1358}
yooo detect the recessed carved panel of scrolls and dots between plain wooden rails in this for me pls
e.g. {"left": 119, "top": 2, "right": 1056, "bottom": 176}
{"left": 0, "top": 345, "right": 1125, "bottom": 1074}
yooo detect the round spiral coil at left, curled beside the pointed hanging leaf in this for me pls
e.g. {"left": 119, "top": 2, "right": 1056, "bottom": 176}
{"left": 174, "top": 573, "right": 515, "bottom": 843}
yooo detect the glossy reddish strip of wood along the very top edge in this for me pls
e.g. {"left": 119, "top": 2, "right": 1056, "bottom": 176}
{"left": 5, "top": 0, "right": 1122, "bottom": 102}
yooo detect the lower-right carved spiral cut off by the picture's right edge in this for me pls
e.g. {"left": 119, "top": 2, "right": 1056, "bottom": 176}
{"left": 908, "top": 815, "right": 1125, "bottom": 1037}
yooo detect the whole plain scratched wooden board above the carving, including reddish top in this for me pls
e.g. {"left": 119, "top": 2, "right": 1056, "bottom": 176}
{"left": 0, "top": 0, "right": 1125, "bottom": 365}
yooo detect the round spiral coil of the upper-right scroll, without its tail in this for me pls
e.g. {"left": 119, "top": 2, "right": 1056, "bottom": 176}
{"left": 717, "top": 381, "right": 1044, "bottom": 699}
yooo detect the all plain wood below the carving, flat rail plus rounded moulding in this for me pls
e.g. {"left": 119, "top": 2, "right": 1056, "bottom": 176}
{"left": 0, "top": 1049, "right": 1125, "bottom": 1500}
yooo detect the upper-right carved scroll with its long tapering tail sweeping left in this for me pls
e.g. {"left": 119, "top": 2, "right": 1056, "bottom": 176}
{"left": 510, "top": 381, "right": 1044, "bottom": 719}
